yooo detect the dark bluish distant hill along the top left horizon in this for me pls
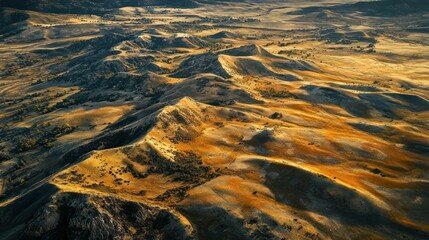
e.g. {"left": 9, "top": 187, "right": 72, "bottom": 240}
{"left": 0, "top": 0, "right": 197, "bottom": 13}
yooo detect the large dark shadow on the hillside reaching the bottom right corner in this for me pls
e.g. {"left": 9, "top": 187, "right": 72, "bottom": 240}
{"left": 249, "top": 159, "right": 429, "bottom": 239}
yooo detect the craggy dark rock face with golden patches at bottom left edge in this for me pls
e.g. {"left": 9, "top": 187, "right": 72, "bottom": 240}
{"left": 22, "top": 192, "right": 195, "bottom": 239}
